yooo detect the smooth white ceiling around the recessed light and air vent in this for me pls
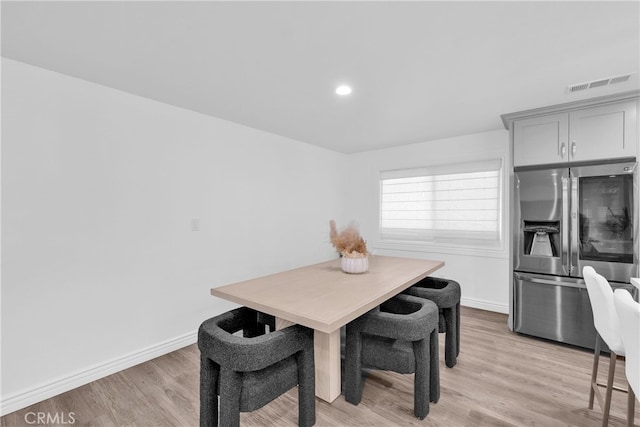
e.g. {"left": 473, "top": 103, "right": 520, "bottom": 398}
{"left": 1, "top": 1, "right": 640, "bottom": 153}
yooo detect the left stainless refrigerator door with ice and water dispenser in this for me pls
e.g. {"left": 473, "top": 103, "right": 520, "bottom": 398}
{"left": 513, "top": 168, "right": 569, "bottom": 276}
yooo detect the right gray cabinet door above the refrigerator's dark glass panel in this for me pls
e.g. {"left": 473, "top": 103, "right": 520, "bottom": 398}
{"left": 569, "top": 101, "right": 638, "bottom": 162}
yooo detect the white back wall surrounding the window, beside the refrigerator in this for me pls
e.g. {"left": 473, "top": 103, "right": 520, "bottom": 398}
{"left": 346, "top": 130, "right": 511, "bottom": 313}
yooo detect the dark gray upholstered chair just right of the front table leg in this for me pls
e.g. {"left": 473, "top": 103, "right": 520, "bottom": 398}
{"left": 344, "top": 295, "right": 440, "bottom": 419}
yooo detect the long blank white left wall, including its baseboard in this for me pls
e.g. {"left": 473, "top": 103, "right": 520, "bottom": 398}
{"left": 0, "top": 59, "right": 346, "bottom": 413}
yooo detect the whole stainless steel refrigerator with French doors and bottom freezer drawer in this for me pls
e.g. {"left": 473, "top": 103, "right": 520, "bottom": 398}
{"left": 512, "top": 159, "right": 639, "bottom": 348}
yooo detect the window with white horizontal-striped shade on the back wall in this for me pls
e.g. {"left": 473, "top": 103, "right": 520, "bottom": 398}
{"left": 380, "top": 159, "right": 502, "bottom": 246}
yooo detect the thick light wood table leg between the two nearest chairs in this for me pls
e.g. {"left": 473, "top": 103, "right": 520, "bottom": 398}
{"left": 276, "top": 317, "right": 341, "bottom": 403}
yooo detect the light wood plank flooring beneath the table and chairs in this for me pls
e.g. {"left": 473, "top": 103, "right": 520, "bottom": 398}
{"left": 0, "top": 307, "right": 640, "bottom": 427}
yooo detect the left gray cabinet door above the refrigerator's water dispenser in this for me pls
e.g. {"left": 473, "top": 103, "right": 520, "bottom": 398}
{"left": 513, "top": 113, "right": 569, "bottom": 166}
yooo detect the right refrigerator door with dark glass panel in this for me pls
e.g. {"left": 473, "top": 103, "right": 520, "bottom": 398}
{"left": 570, "top": 162, "right": 638, "bottom": 283}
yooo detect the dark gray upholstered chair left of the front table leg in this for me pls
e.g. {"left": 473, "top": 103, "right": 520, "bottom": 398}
{"left": 198, "top": 307, "right": 316, "bottom": 426}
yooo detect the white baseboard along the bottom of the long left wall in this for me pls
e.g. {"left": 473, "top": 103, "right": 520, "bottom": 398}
{"left": 0, "top": 332, "right": 198, "bottom": 416}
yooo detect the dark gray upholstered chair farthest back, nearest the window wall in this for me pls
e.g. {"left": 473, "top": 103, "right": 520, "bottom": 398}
{"left": 404, "top": 277, "right": 461, "bottom": 368}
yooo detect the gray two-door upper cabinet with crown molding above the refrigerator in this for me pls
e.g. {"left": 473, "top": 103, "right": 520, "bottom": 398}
{"left": 502, "top": 94, "right": 638, "bottom": 166}
